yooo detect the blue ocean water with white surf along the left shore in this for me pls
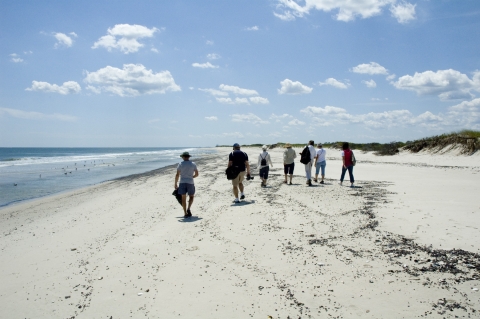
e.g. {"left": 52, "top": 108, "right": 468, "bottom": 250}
{"left": 0, "top": 147, "right": 216, "bottom": 207}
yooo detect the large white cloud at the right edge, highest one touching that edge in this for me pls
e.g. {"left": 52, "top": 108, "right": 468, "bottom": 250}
{"left": 392, "top": 69, "right": 480, "bottom": 101}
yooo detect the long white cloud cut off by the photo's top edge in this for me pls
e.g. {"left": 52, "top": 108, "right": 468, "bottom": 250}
{"left": 274, "top": 0, "right": 415, "bottom": 23}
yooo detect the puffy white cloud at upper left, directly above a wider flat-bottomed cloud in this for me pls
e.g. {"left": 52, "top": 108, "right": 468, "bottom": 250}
{"left": 92, "top": 24, "right": 160, "bottom": 54}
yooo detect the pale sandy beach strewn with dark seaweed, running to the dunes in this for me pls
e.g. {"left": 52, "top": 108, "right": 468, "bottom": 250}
{"left": 0, "top": 148, "right": 480, "bottom": 319}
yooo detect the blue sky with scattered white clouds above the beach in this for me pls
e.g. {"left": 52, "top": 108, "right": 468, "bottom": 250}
{"left": 0, "top": 0, "right": 480, "bottom": 147}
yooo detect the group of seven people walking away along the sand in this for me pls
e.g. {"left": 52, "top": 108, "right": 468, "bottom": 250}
{"left": 175, "top": 144, "right": 355, "bottom": 218}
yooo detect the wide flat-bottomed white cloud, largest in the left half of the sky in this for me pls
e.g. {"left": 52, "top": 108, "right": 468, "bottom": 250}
{"left": 84, "top": 64, "right": 181, "bottom": 96}
